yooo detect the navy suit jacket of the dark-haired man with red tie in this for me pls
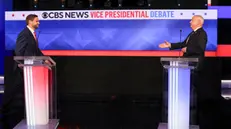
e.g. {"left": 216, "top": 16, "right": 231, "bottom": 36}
{"left": 15, "top": 27, "right": 43, "bottom": 56}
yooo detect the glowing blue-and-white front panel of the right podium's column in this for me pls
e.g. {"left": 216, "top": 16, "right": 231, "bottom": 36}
{"left": 168, "top": 62, "right": 191, "bottom": 129}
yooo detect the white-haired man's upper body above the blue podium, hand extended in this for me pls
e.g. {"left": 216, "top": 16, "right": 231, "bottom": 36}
{"left": 159, "top": 15, "right": 207, "bottom": 58}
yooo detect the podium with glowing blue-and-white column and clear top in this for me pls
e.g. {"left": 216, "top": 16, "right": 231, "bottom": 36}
{"left": 160, "top": 57, "right": 198, "bottom": 129}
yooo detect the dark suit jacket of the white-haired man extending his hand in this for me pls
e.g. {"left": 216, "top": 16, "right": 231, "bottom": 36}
{"left": 170, "top": 28, "right": 207, "bottom": 57}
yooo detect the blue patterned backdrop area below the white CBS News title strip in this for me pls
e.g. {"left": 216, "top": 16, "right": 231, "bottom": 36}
{"left": 5, "top": 20, "right": 217, "bottom": 50}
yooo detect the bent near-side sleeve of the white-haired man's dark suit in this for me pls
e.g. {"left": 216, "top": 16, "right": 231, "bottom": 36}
{"left": 186, "top": 32, "right": 207, "bottom": 54}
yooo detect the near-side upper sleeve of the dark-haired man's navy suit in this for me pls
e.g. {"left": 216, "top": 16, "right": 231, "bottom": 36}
{"left": 15, "top": 34, "right": 28, "bottom": 56}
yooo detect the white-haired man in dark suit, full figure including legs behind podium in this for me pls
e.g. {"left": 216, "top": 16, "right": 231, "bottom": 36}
{"left": 159, "top": 15, "right": 220, "bottom": 129}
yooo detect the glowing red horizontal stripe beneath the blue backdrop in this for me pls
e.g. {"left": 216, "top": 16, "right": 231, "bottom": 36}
{"left": 43, "top": 45, "right": 231, "bottom": 57}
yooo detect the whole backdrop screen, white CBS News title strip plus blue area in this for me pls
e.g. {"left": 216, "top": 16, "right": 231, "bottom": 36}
{"left": 5, "top": 10, "right": 217, "bottom": 51}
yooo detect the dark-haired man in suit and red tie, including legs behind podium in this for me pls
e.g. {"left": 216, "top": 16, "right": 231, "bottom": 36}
{"left": 2, "top": 14, "right": 49, "bottom": 129}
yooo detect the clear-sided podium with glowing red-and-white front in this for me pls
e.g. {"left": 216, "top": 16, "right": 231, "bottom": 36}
{"left": 14, "top": 56, "right": 59, "bottom": 129}
